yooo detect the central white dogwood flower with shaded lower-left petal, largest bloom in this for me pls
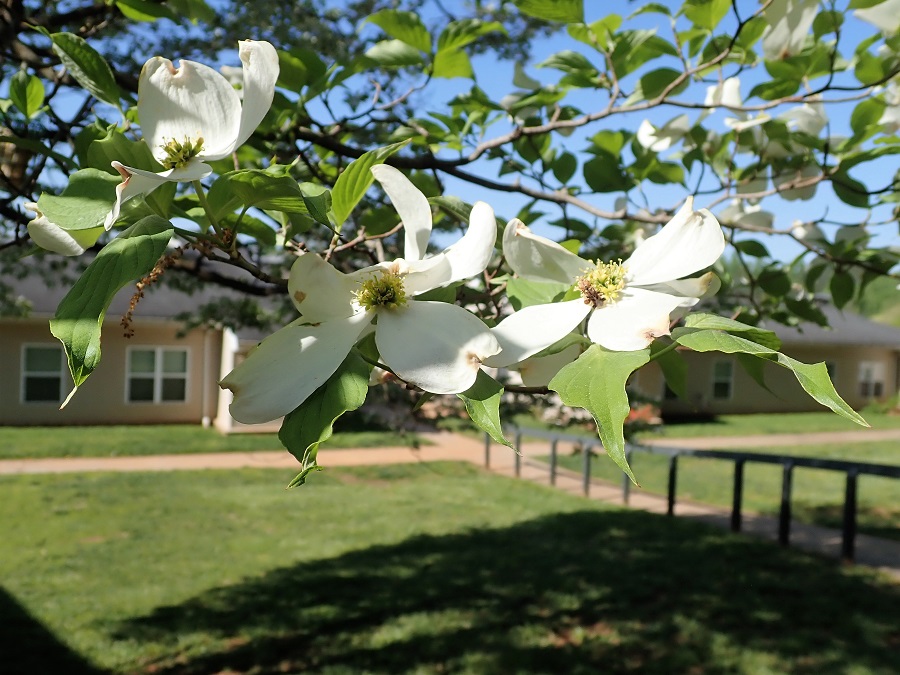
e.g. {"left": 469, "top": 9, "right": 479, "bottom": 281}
{"left": 220, "top": 165, "right": 500, "bottom": 424}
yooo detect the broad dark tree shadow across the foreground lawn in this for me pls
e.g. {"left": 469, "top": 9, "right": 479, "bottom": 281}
{"left": 118, "top": 511, "right": 900, "bottom": 674}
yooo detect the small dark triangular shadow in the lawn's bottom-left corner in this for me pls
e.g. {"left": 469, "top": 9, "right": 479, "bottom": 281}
{"left": 0, "top": 587, "right": 106, "bottom": 675}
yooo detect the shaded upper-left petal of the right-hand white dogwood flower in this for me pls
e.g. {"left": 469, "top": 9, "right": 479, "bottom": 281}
{"left": 503, "top": 218, "right": 594, "bottom": 284}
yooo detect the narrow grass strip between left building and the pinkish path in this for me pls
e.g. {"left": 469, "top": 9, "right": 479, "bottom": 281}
{"left": 0, "top": 425, "right": 415, "bottom": 459}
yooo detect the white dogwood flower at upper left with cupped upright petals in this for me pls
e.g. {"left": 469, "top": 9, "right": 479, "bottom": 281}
{"left": 104, "top": 40, "right": 279, "bottom": 229}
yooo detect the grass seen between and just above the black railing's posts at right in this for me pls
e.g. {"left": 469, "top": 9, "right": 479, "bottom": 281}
{"left": 544, "top": 441, "right": 900, "bottom": 539}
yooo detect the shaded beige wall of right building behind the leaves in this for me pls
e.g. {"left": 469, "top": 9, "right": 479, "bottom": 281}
{"left": 630, "top": 345, "right": 900, "bottom": 414}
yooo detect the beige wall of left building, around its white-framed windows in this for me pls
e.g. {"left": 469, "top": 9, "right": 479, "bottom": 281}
{"left": 0, "top": 319, "right": 222, "bottom": 425}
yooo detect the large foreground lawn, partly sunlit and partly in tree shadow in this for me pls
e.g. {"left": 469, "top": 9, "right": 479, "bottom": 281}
{"left": 0, "top": 464, "right": 900, "bottom": 675}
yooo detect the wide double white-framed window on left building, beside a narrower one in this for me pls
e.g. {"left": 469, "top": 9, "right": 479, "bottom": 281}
{"left": 126, "top": 347, "right": 188, "bottom": 403}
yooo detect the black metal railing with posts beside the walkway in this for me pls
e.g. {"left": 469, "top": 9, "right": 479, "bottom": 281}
{"left": 484, "top": 427, "right": 900, "bottom": 561}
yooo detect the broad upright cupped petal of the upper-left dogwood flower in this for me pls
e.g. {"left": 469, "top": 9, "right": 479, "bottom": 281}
{"left": 138, "top": 56, "right": 241, "bottom": 161}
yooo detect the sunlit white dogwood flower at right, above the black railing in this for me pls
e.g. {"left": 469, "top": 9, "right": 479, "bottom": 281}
{"left": 485, "top": 198, "right": 725, "bottom": 367}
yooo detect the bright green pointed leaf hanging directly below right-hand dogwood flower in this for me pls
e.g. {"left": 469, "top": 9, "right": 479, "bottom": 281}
{"left": 549, "top": 345, "right": 650, "bottom": 483}
